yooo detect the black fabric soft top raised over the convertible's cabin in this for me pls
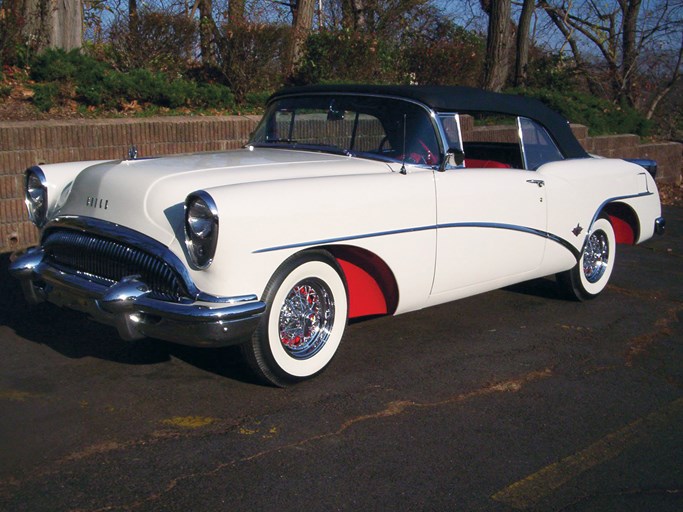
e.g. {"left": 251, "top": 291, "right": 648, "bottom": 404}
{"left": 269, "top": 84, "right": 588, "bottom": 158}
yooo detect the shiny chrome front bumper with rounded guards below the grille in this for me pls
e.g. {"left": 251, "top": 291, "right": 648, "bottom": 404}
{"left": 9, "top": 248, "right": 266, "bottom": 347}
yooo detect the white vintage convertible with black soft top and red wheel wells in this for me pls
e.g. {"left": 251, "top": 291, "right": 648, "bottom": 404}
{"left": 11, "top": 85, "right": 664, "bottom": 386}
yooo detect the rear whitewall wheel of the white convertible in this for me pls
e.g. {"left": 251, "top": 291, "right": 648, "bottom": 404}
{"left": 557, "top": 217, "right": 616, "bottom": 301}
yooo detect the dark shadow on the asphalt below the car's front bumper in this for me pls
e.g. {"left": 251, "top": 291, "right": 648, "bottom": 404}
{"left": 0, "top": 254, "right": 256, "bottom": 383}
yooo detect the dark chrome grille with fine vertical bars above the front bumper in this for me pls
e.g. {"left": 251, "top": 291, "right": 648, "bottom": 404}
{"left": 42, "top": 230, "right": 189, "bottom": 301}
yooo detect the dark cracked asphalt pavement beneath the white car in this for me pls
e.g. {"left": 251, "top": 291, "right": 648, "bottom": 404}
{"left": 0, "top": 207, "right": 683, "bottom": 512}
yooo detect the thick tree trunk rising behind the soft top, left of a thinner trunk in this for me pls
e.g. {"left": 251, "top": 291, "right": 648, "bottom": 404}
{"left": 482, "top": 0, "right": 511, "bottom": 91}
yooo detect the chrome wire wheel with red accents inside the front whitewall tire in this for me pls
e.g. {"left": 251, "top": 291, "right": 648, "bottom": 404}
{"left": 279, "top": 279, "right": 334, "bottom": 359}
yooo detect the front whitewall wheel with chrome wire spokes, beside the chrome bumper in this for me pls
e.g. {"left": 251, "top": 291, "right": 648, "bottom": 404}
{"left": 242, "top": 251, "right": 348, "bottom": 387}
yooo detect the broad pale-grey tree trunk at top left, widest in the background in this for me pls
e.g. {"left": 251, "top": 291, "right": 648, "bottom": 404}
{"left": 22, "top": 0, "right": 83, "bottom": 52}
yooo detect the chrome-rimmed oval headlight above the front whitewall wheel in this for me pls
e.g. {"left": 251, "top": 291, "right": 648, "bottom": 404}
{"left": 184, "top": 190, "right": 218, "bottom": 270}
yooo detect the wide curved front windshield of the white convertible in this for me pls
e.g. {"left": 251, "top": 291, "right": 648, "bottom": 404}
{"left": 249, "top": 95, "right": 441, "bottom": 166}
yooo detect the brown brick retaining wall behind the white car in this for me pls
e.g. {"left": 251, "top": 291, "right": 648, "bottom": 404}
{"left": 0, "top": 116, "right": 683, "bottom": 253}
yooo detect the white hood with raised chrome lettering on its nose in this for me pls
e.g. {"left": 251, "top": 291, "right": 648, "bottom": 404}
{"left": 55, "top": 148, "right": 388, "bottom": 245}
